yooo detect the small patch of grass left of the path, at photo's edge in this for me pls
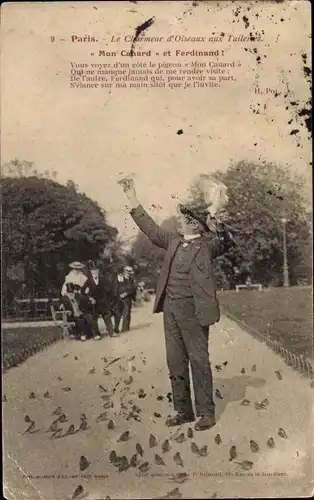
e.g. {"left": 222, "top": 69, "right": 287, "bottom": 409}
{"left": 2, "top": 325, "right": 62, "bottom": 370}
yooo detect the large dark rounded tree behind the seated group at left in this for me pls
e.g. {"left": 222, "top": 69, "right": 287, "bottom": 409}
{"left": 2, "top": 172, "right": 117, "bottom": 293}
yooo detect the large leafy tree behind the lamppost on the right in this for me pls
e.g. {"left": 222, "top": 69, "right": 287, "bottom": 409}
{"left": 191, "top": 161, "right": 311, "bottom": 285}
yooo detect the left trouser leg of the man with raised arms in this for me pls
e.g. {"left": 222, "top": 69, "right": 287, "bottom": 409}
{"left": 164, "top": 297, "right": 193, "bottom": 415}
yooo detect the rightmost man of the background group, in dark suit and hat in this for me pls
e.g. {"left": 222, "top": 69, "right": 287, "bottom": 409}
{"left": 115, "top": 266, "right": 136, "bottom": 332}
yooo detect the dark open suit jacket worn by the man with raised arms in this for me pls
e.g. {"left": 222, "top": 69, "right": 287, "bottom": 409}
{"left": 131, "top": 205, "right": 235, "bottom": 326}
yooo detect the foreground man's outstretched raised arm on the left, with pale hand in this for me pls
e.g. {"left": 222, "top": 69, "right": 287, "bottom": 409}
{"left": 118, "top": 180, "right": 171, "bottom": 250}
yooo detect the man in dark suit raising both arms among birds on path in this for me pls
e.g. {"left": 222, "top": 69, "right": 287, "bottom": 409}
{"left": 120, "top": 180, "right": 235, "bottom": 431}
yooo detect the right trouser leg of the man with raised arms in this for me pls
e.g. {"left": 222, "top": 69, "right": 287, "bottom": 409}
{"left": 173, "top": 298, "right": 215, "bottom": 416}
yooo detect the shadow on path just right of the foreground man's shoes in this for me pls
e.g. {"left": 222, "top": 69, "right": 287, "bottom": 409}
{"left": 214, "top": 375, "right": 266, "bottom": 421}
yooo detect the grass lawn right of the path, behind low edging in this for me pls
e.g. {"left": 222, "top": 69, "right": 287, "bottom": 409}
{"left": 219, "top": 287, "right": 313, "bottom": 358}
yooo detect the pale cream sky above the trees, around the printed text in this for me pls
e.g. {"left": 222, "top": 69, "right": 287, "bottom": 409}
{"left": 1, "top": 1, "right": 311, "bottom": 246}
